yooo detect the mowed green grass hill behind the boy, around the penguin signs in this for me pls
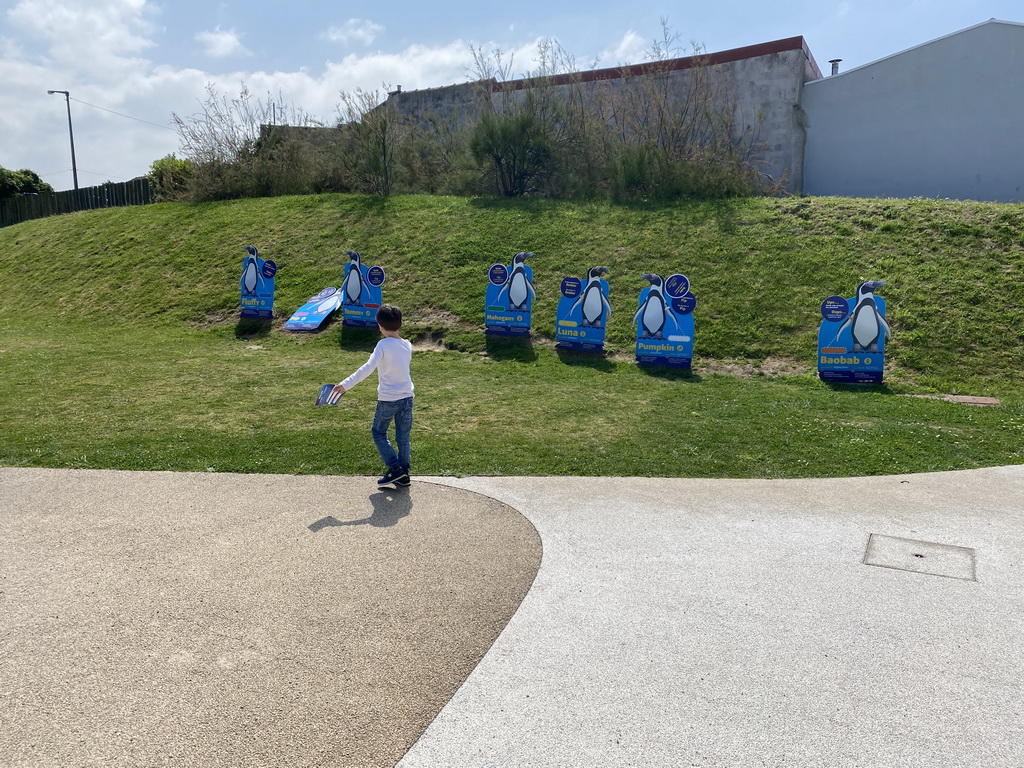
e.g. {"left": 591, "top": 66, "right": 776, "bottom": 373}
{"left": 0, "top": 195, "right": 1024, "bottom": 477}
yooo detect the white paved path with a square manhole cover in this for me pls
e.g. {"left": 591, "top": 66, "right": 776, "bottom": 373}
{"left": 399, "top": 467, "right": 1024, "bottom": 768}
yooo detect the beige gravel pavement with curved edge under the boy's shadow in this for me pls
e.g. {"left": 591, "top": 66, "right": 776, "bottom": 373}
{"left": 0, "top": 469, "right": 541, "bottom": 768}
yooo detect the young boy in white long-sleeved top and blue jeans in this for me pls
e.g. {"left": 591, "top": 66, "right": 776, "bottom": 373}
{"left": 328, "top": 304, "right": 413, "bottom": 487}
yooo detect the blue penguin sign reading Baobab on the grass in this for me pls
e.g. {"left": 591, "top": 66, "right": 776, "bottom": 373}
{"left": 818, "top": 281, "right": 892, "bottom": 384}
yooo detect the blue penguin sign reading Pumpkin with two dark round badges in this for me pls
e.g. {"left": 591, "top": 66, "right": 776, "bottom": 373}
{"left": 633, "top": 274, "right": 697, "bottom": 368}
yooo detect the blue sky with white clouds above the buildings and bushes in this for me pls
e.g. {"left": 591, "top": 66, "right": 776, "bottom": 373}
{"left": 0, "top": 0, "right": 1024, "bottom": 189}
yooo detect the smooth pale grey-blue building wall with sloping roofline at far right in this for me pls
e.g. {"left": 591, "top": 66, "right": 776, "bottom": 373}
{"left": 803, "top": 20, "right": 1024, "bottom": 202}
